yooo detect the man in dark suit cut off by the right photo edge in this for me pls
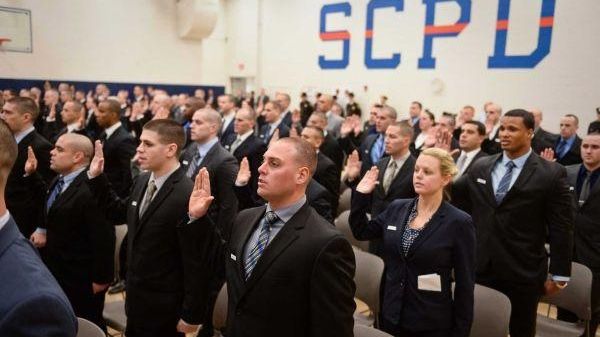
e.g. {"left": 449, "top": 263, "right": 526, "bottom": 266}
{"left": 558, "top": 132, "right": 600, "bottom": 336}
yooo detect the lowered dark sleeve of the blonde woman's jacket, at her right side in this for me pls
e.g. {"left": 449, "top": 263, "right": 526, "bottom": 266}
{"left": 452, "top": 217, "right": 475, "bottom": 337}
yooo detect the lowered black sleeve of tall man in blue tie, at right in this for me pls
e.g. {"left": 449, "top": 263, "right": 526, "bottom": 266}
{"left": 545, "top": 165, "right": 574, "bottom": 276}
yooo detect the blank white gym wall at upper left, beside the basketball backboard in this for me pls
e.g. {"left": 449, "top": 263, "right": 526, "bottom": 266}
{"left": 0, "top": 0, "right": 227, "bottom": 85}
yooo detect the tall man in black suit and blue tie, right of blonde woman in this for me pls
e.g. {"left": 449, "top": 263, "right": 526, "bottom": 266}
{"left": 453, "top": 109, "right": 573, "bottom": 337}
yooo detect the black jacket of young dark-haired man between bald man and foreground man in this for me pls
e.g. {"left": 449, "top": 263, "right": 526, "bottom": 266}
{"left": 87, "top": 167, "right": 211, "bottom": 329}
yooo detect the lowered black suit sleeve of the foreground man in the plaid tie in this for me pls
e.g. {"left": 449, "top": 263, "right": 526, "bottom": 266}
{"left": 308, "top": 236, "right": 356, "bottom": 337}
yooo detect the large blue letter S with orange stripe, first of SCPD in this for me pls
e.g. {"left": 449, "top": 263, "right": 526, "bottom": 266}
{"left": 319, "top": 2, "right": 352, "bottom": 69}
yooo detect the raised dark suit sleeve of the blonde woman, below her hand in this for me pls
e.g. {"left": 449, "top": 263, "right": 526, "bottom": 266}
{"left": 349, "top": 190, "right": 391, "bottom": 240}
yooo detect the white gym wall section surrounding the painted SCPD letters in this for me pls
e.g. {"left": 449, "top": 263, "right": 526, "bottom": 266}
{"left": 252, "top": 0, "right": 600, "bottom": 134}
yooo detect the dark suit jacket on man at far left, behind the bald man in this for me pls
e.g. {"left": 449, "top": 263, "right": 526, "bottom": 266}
{"left": 6, "top": 131, "right": 54, "bottom": 238}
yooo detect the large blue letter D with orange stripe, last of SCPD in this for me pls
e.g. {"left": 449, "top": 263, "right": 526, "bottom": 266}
{"left": 488, "top": 0, "right": 556, "bottom": 68}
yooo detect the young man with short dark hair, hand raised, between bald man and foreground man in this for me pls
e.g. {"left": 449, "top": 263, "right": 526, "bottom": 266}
{"left": 87, "top": 119, "right": 211, "bottom": 337}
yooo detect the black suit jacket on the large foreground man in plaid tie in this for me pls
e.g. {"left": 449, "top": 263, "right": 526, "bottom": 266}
{"left": 205, "top": 204, "right": 355, "bottom": 337}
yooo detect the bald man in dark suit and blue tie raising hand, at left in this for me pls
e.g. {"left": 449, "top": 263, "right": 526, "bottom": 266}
{"left": 25, "top": 133, "right": 115, "bottom": 331}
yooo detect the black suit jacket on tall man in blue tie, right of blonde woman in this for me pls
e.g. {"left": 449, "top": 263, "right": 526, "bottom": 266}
{"left": 453, "top": 153, "right": 573, "bottom": 286}
